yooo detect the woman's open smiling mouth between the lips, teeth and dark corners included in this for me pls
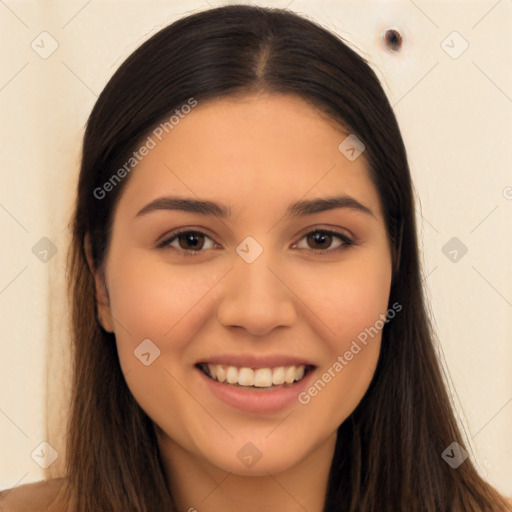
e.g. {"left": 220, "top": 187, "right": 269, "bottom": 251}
{"left": 195, "top": 363, "right": 315, "bottom": 391}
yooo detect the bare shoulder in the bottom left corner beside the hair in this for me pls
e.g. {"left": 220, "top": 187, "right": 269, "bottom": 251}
{"left": 0, "top": 478, "right": 66, "bottom": 512}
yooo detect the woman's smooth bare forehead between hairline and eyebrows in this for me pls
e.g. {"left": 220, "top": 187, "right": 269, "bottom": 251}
{"left": 114, "top": 95, "right": 381, "bottom": 224}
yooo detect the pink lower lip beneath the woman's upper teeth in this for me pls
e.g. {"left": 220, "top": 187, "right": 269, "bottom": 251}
{"left": 196, "top": 368, "right": 314, "bottom": 414}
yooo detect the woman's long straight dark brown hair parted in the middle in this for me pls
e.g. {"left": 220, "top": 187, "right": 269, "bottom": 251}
{"left": 66, "top": 5, "right": 509, "bottom": 512}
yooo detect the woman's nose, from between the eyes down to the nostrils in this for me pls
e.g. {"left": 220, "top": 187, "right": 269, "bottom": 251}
{"left": 217, "top": 252, "right": 297, "bottom": 336}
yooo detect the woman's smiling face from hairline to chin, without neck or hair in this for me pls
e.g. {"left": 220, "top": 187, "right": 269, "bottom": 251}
{"left": 91, "top": 95, "right": 391, "bottom": 475}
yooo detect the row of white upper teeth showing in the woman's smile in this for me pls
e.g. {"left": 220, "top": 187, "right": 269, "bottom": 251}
{"left": 205, "top": 364, "right": 306, "bottom": 388}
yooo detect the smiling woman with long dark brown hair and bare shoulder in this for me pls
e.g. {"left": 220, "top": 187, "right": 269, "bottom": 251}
{"left": 0, "top": 6, "right": 512, "bottom": 512}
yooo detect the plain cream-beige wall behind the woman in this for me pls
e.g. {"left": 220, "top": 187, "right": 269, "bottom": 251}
{"left": 0, "top": 0, "right": 512, "bottom": 495}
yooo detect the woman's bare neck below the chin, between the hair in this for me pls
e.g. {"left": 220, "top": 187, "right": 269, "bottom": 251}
{"left": 156, "top": 429, "right": 336, "bottom": 512}
